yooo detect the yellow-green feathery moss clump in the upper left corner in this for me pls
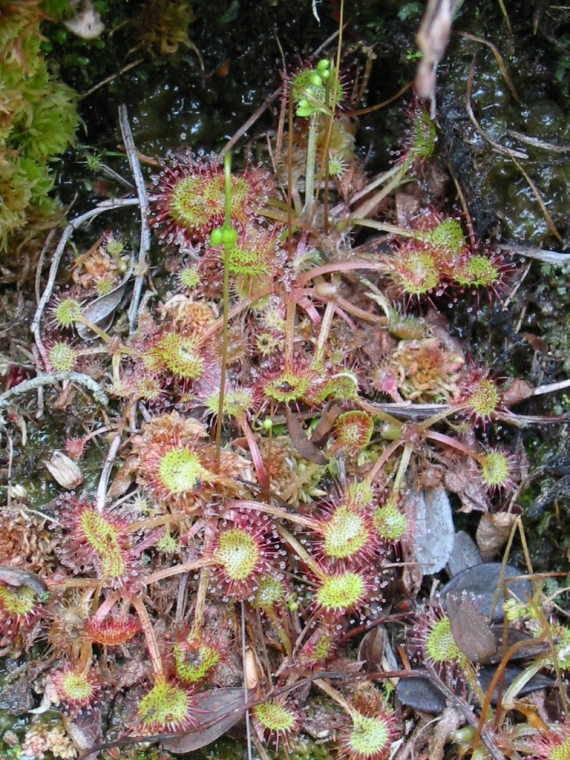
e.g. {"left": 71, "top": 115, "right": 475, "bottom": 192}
{"left": 0, "top": 0, "right": 79, "bottom": 250}
